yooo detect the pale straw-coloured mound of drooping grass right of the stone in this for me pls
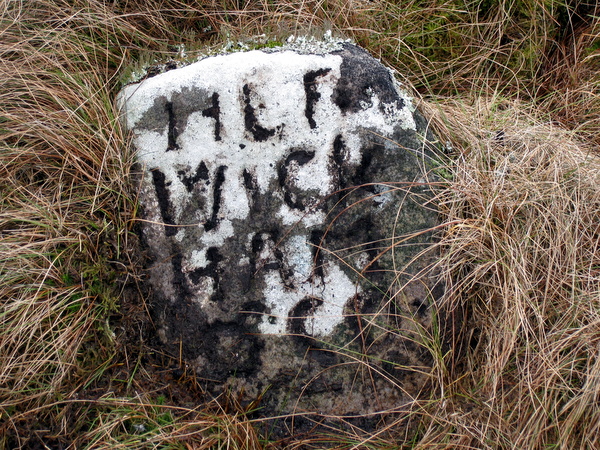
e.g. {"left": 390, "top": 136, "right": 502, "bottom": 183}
{"left": 412, "top": 99, "right": 600, "bottom": 448}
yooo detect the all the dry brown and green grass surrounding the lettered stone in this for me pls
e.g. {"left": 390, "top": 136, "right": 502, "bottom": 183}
{"left": 0, "top": 0, "right": 600, "bottom": 449}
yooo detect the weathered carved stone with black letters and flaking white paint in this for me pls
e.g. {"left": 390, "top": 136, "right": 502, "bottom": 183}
{"left": 119, "top": 43, "right": 436, "bottom": 432}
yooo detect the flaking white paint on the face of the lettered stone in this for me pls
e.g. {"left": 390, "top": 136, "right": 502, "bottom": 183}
{"left": 119, "top": 45, "right": 415, "bottom": 335}
